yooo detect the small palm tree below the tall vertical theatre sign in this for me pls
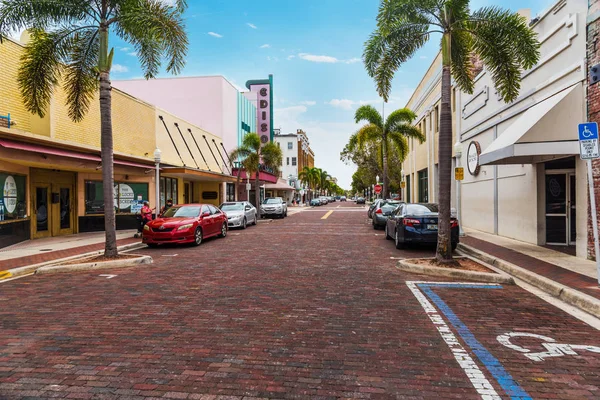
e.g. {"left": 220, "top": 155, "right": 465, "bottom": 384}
{"left": 231, "top": 133, "right": 283, "bottom": 218}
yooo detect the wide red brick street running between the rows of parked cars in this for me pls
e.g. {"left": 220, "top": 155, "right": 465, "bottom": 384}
{"left": 0, "top": 203, "right": 600, "bottom": 399}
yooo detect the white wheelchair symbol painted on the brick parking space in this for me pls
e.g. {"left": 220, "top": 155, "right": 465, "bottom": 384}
{"left": 496, "top": 332, "right": 600, "bottom": 361}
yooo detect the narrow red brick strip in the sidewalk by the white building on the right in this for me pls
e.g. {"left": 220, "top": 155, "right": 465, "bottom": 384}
{"left": 461, "top": 237, "right": 600, "bottom": 299}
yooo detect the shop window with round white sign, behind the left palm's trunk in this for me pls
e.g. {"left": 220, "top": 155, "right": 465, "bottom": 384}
{"left": 84, "top": 181, "right": 149, "bottom": 214}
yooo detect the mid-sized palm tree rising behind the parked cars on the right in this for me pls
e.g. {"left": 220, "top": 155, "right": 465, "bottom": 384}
{"left": 348, "top": 105, "right": 425, "bottom": 199}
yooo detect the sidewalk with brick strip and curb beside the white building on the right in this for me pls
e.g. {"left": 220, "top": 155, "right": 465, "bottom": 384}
{"left": 459, "top": 230, "right": 600, "bottom": 317}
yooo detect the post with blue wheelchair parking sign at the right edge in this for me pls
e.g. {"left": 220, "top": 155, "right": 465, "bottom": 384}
{"left": 578, "top": 122, "right": 600, "bottom": 286}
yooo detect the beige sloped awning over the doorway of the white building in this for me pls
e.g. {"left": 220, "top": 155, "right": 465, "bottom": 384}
{"left": 479, "top": 83, "right": 584, "bottom": 165}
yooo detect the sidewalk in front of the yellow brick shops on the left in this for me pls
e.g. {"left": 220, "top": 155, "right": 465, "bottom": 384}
{"left": 0, "top": 230, "right": 141, "bottom": 271}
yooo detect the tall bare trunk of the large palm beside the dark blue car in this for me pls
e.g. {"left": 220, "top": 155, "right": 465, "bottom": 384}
{"left": 436, "top": 34, "right": 452, "bottom": 263}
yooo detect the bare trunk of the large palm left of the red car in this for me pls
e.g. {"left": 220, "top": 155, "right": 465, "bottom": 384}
{"left": 100, "top": 72, "right": 118, "bottom": 257}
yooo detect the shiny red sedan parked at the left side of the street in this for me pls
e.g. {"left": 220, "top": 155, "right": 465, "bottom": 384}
{"left": 142, "top": 204, "right": 227, "bottom": 247}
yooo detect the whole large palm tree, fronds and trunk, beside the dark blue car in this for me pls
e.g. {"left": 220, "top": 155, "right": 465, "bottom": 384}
{"left": 363, "top": 0, "right": 540, "bottom": 263}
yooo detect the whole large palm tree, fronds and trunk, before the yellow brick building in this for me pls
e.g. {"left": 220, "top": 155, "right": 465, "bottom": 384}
{"left": 0, "top": 0, "right": 188, "bottom": 257}
